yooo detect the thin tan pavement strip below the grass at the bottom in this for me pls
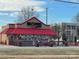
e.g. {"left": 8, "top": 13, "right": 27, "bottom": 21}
{"left": 0, "top": 55, "right": 79, "bottom": 58}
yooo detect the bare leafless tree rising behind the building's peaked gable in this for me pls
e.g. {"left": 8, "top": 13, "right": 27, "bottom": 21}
{"left": 17, "top": 7, "right": 39, "bottom": 22}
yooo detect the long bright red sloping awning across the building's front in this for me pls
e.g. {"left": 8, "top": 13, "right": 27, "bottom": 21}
{"left": 1, "top": 28, "right": 57, "bottom": 36}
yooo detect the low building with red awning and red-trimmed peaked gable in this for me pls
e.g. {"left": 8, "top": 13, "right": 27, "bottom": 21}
{"left": 0, "top": 17, "right": 56, "bottom": 46}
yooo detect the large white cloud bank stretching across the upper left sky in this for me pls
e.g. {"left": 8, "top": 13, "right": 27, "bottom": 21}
{"left": 0, "top": 0, "right": 45, "bottom": 11}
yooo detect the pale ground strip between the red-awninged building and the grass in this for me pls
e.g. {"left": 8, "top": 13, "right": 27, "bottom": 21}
{"left": 0, "top": 45, "right": 79, "bottom": 49}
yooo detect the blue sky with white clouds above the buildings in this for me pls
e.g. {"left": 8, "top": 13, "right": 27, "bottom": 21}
{"left": 0, "top": 0, "right": 79, "bottom": 28}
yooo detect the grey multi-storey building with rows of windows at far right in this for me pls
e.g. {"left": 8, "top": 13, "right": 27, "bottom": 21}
{"left": 61, "top": 23, "right": 79, "bottom": 44}
